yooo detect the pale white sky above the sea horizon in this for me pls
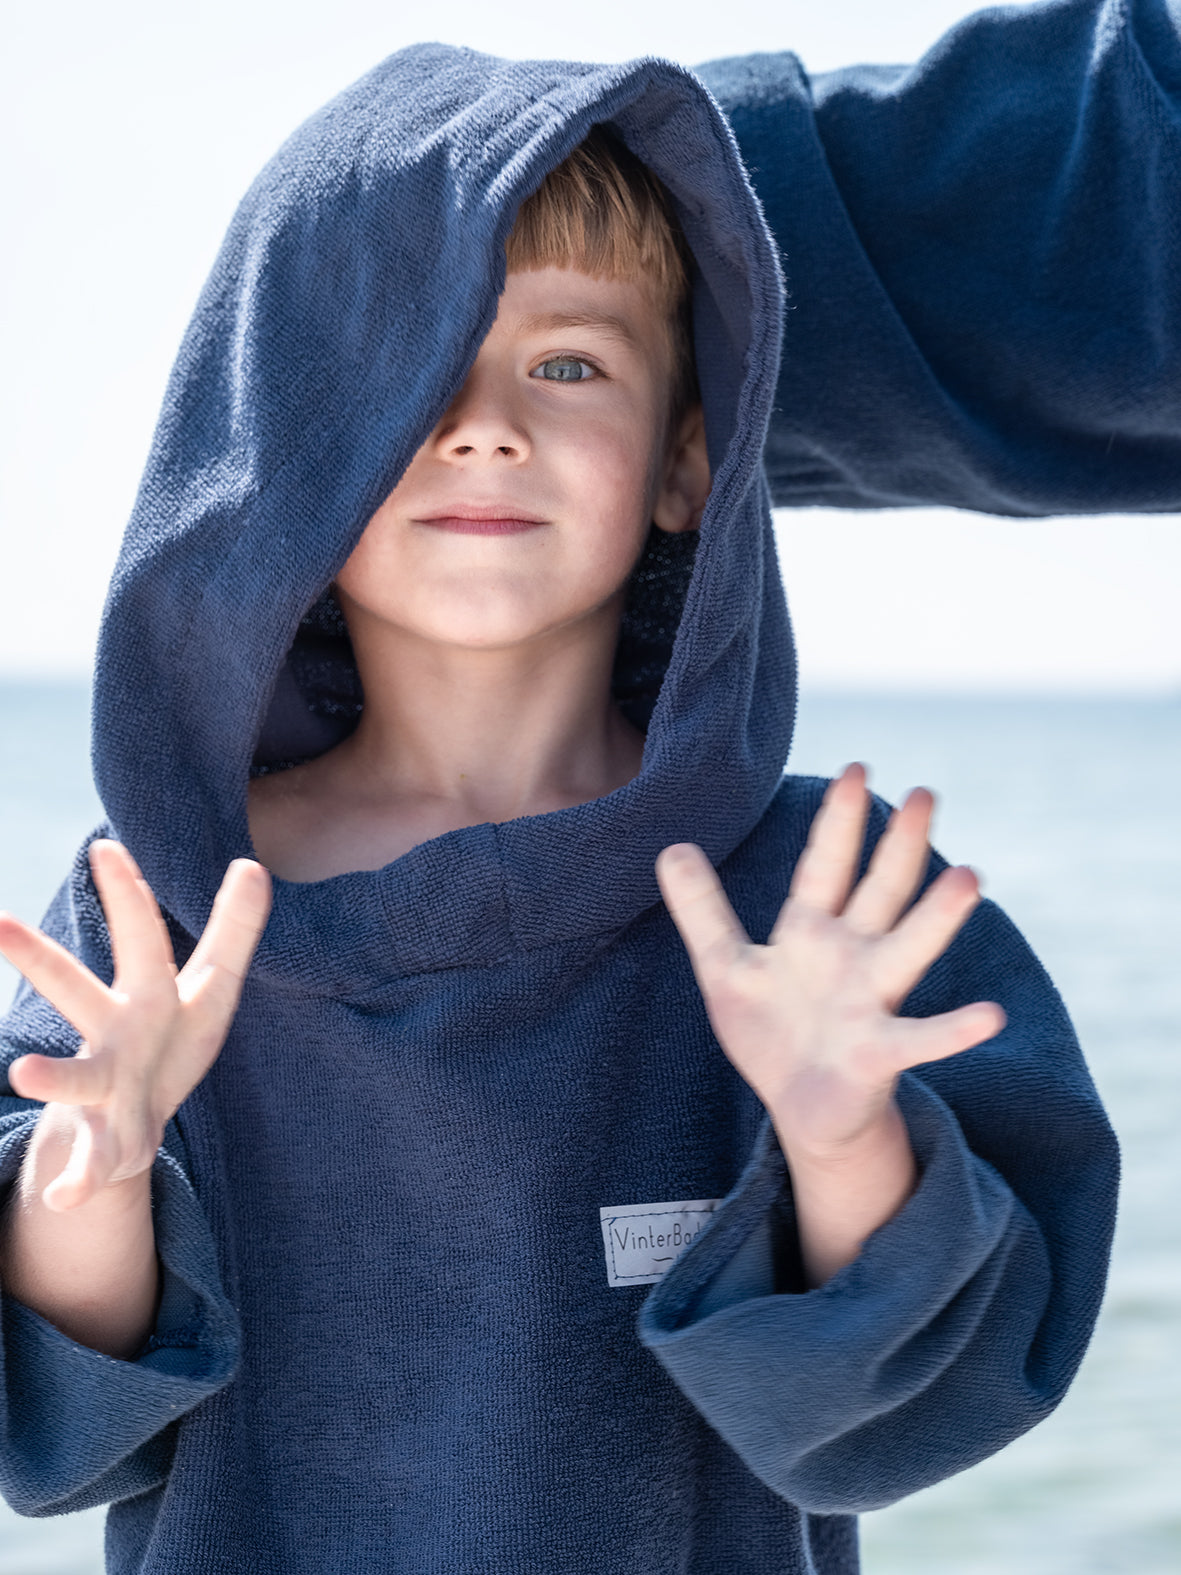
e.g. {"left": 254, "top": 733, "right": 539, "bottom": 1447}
{"left": 0, "top": 0, "right": 1181, "bottom": 690}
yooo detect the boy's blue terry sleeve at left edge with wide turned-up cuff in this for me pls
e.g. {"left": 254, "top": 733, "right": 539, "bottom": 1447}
{"left": 0, "top": 833, "right": 239, "bottom": 1515}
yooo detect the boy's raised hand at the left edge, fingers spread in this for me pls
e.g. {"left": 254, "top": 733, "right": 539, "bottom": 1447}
{"left": 0, "top": 839, "right": 271, "bottom": 1210}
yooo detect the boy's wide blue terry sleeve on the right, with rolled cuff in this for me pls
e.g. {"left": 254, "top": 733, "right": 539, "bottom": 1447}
{"left": 639, "top": 865, "right": 1118, "bottom": 1514}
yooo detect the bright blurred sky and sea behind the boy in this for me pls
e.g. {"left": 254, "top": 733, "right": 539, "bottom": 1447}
{"left": 0, "top": 0, "right": 1181, "bottom": 1575}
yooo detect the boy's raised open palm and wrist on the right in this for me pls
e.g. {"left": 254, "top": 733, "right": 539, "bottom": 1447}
{"left": 657, "top": 765, "right": 1005, "bottom": 1284}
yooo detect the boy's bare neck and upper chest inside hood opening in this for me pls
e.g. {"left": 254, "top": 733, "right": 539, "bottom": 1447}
{"left": 269, "top": 603, "right": 644, "bottom": 879}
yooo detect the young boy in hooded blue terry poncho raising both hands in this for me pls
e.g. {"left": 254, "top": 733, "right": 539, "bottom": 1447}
{"left": 0, "top": 9, "right": 1140, "bottom": 1575}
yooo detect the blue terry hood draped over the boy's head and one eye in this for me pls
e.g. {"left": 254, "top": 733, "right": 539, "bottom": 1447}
{"left": 94, "top": 44, "right": 795, "bottom": 997}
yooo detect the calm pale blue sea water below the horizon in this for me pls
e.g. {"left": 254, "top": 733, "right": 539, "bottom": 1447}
{"left": 0, "top": 685, "right": 1181, "bottom": 1575}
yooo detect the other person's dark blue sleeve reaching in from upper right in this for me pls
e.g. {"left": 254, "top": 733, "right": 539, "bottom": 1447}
{"left": 698, "top": 0, "right": 1181, "bottom": 515}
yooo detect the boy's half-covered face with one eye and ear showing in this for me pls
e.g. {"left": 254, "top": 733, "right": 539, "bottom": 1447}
{"left": 337, "top": 268, "right": 709, "bottom": 649}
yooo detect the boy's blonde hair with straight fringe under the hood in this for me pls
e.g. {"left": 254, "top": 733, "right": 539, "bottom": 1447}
{"left": 504, "top": 126, "right": 699, "bottom": 425}
